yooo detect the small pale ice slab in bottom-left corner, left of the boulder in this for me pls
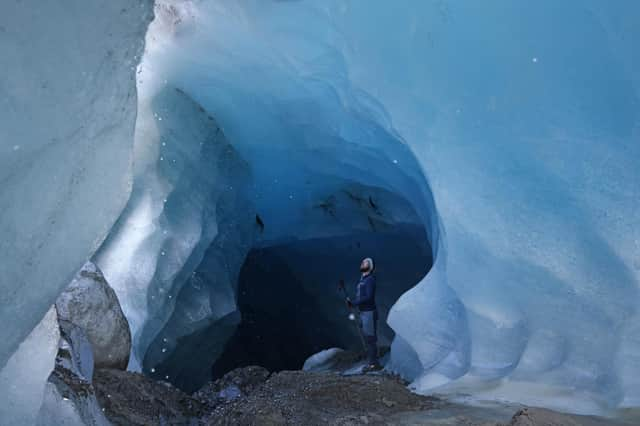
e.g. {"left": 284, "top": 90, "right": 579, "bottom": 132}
{"left": 0, "top": 306, "right": 60, "bottom": 426}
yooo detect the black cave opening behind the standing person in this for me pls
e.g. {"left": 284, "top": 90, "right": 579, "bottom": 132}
{"left": 212, "top": 224, "right": 433, "bottom": 379}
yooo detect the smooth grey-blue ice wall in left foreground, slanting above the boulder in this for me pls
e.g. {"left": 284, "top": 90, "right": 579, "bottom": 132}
{"left": 0, "top": 0, "right": 152, "bottom": 367}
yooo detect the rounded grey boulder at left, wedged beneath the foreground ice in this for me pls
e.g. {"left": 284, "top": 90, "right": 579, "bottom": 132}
{"left": 56, "top": 262, "right": 131, "bottom": 370}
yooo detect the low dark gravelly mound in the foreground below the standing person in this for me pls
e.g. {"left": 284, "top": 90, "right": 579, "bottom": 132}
{"left": 204, "top": 371, "right": 436, "bottom": 425}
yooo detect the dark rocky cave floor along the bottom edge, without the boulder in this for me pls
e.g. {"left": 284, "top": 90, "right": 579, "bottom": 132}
{"left": 93, "top": 367, "right": 633, "bottom": 426}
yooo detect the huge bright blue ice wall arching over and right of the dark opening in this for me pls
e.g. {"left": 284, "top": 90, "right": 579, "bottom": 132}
{"left": 143, "top": 0, "right": 640, "bottom": 412}
